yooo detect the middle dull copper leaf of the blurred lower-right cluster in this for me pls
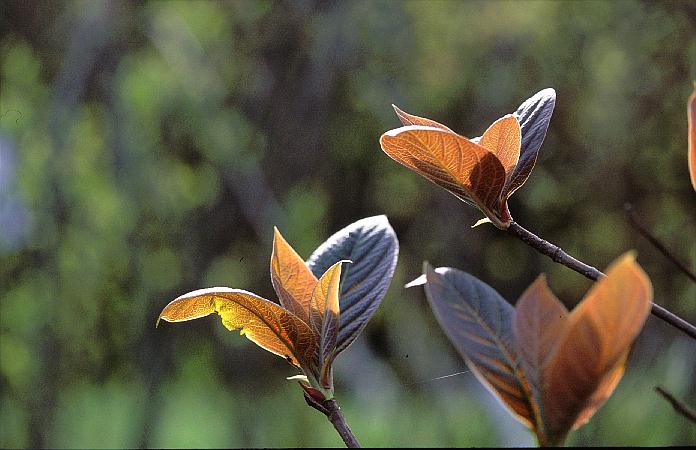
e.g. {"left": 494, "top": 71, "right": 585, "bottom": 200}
{"left": 513, "top": 275, "right": 568, "bottom": 436}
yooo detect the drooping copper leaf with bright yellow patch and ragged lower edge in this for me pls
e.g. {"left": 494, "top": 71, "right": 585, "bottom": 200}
{"left": 158, "top": 287, "right": 317, "bottom": 367}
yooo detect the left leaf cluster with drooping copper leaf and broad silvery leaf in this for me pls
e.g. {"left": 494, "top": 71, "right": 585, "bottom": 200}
{"left": 159, "top": 216, "right": 399, "bottom": 401}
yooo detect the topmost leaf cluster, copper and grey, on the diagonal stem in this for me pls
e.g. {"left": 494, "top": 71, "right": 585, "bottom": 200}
{"left": 380, "top": 88, "right": 556, "bottom": 229}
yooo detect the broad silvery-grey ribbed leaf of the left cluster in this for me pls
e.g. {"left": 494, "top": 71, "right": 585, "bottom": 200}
{"left": 307, "top": 216, "right": 399, "bottom": 355}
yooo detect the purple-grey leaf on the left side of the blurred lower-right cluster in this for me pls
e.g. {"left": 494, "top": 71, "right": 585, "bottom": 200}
{"left": 423, "top": 263, "right": 536, "bottom": 428}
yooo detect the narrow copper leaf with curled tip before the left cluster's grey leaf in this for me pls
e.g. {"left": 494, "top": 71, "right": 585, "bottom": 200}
{"left": 309, "top": 261, "right": 346, "bottom": 388}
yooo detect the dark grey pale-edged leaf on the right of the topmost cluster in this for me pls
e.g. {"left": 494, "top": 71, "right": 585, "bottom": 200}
{"left": 505, "top": 88, "right": 556, "bottom": 197}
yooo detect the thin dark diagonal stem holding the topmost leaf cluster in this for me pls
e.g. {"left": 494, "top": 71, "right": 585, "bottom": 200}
{"left": 508, "top": 222, "right": 696, "bottom": 339}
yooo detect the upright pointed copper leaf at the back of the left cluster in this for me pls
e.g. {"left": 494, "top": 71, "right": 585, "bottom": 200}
{"left": 271, "top": 227, "right": 317, "bottom": 323}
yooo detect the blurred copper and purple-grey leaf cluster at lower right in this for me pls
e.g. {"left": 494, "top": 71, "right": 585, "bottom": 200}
{"left": 406, "top": 252, "right": 652, "bottom": 445}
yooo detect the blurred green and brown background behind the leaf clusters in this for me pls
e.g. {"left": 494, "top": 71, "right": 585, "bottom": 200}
{"left": 0, "top": 0, "right": 696, "bottom": 447}
